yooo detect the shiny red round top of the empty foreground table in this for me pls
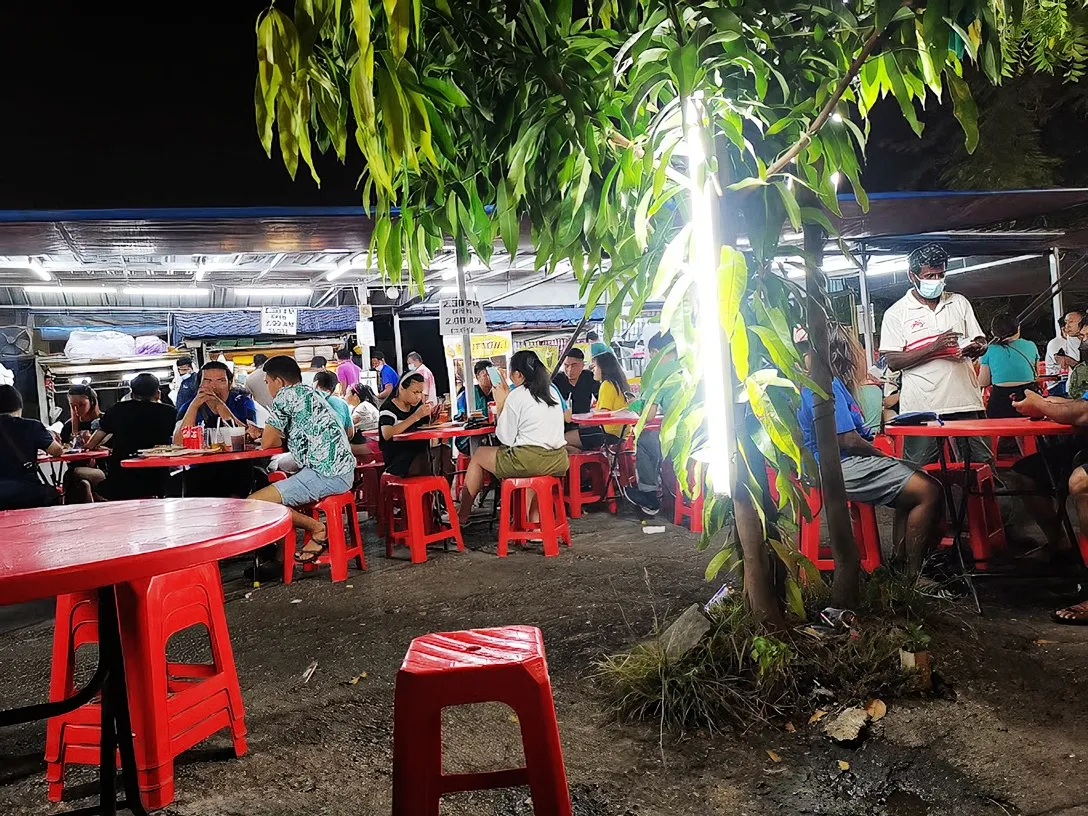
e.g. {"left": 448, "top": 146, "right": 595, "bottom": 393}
{"left": 0, "top": 498, "right": 292, "bottom": 605}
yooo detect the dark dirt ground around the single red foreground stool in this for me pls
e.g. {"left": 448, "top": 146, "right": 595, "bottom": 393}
{"left": 0, "top": 514, "right": 1088, "bottom": 816}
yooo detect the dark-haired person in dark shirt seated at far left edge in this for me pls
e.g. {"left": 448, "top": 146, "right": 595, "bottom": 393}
{"left": 0, "top": 385, "right": 64, "bottom": 510}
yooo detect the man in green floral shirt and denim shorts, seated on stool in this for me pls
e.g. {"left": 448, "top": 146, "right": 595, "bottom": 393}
{"left": 250, "top": 356, "right": 355, "bottom": 564}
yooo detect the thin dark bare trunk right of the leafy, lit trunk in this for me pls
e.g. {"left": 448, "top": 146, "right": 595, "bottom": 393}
{"left": 805, "top": 224, "right": 862, "bottom": 608}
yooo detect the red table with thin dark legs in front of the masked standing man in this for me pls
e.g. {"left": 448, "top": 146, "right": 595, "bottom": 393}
{"left": 885, "top": 417, "right": 1077, "bottom": 613}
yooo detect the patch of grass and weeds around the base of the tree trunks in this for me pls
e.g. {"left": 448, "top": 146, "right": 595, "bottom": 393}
{"left": 595, "top": 572, "right": 949, "bottom": 734}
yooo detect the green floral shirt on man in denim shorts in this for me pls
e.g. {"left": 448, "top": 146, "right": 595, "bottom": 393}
{"left": 268, "top": 384, "right": 355, "bottom": 477}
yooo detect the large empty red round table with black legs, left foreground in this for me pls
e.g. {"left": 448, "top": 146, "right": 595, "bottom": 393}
{"left": 0, "top": 498, "right": 292, "bottom": 814}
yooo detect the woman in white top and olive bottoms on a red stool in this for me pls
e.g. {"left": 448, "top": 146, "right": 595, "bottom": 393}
{"left": 459, "top": 350, "right": 570, "bottom": 520}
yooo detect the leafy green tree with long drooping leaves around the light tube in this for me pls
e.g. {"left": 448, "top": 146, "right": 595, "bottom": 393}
{"left": 255, "top": 0, "right": 1023, "bottom": 627}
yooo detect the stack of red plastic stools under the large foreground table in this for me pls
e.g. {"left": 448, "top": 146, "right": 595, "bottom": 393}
{"left": 46, "top": 564, "right": 247, "bottom": 809}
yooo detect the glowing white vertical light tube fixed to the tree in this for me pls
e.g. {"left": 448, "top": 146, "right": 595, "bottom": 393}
{"left": 683, "top": 94, "right": 737, "bottom": 494}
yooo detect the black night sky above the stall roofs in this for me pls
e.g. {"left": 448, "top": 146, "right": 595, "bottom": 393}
{"left": 0, "top": 7, "right": 926, "bottom": 209}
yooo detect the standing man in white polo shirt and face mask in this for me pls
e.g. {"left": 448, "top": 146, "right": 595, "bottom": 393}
{"left": 880, "top": 244, "right": 992, "bottom": 465}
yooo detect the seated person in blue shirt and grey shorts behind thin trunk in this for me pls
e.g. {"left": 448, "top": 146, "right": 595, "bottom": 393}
{"left": 798, "top": 337, "right": 942, "bottom": 576}
